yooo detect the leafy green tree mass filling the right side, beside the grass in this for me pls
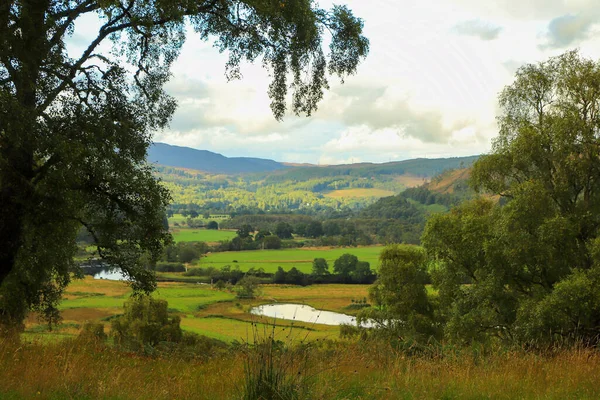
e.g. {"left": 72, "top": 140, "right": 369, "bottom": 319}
{"left": 423, "top": 51, "right": 600, "bottom": 343}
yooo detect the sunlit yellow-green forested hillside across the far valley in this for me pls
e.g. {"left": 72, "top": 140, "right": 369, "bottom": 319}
{"left": 156, "top": 149, "right": 477, "bottom": 215}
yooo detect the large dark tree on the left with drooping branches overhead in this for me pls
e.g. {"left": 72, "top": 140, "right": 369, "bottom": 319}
{"left": 0, "top": 0, "right": 368, "bottom": 330}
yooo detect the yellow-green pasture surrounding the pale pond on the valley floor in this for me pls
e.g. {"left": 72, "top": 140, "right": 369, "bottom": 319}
{"left": 24, "top": 276, "right": 368, "bottom": 342}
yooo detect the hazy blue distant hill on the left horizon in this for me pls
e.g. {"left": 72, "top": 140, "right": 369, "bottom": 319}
{"left": 148, "top": 143, "right": 287, "bottom": 174}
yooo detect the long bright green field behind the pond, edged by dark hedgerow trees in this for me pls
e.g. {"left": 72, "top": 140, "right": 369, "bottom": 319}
{"left": 199, "top": 246, "right": 384, "bottom": 273}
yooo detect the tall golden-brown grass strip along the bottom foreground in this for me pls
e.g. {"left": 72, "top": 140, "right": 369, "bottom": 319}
{"left": 0, "top": 340, "right": 600, "bottom": 399}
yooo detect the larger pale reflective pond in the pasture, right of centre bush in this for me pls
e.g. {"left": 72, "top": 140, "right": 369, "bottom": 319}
{"left": 250, "top": 304, "right": 374, "bottom": 328}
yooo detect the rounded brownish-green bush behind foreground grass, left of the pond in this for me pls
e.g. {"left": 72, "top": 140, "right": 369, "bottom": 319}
{"left": 111, "top": 296, "right": 183, "bottom": 350}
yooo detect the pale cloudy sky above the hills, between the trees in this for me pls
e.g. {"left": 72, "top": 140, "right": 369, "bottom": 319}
{"left": 75, "top": 0, "right": 600, "bottom": 164}
